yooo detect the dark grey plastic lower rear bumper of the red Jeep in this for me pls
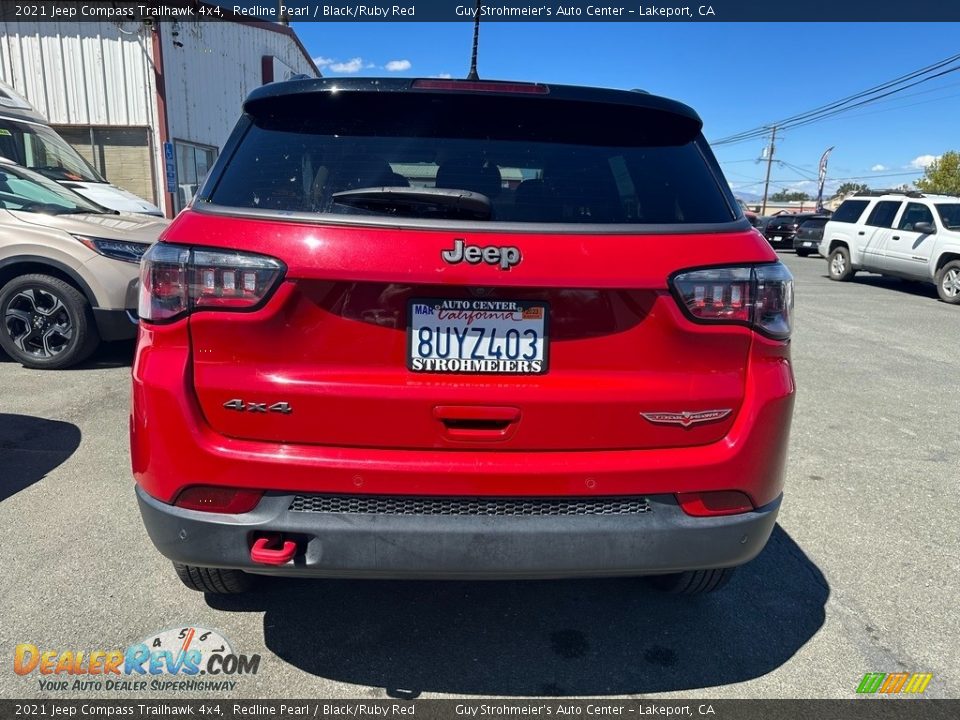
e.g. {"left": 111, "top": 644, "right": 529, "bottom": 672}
{"left": 137, "top": 487, "right": 782, "bottom": 578}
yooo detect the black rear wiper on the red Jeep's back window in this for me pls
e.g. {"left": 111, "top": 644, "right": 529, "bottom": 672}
{"left": 333, "top": 187, "right": 493, "bottom": 220}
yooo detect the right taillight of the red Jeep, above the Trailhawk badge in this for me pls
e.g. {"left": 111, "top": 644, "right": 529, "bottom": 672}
{"left": 672, "top": 262, "right": 793, "bottom": 340}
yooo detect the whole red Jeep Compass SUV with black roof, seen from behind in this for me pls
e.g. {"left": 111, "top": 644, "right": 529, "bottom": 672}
{"left": 130, "top": 79, "right": 794, "bottom": 593}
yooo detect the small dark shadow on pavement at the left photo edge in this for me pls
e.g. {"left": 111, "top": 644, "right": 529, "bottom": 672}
{"left": 0, "top": 413, "right": 80, "bottom": 501}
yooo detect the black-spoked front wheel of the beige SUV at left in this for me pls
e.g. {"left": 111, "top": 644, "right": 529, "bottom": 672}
{"left": 0, "top": 274, "right": 100, "bottom": 370}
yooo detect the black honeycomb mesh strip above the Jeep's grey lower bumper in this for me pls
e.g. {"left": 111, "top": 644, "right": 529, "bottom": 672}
{"left": 290, "top": 495, "right": 653, "bottom": 517}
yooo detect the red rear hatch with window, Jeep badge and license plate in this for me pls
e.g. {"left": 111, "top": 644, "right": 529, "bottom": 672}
{"left": 184, "top": 83, "right": 774, "bottom": 450}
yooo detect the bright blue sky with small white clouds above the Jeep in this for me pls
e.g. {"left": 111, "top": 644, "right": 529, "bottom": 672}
{"left": 293, "top": 22, "right": 960, "bottom": 200}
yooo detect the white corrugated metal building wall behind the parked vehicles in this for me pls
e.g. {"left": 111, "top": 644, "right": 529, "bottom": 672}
{"left": 0, "top": 21, "right": 317, "bottom": 213}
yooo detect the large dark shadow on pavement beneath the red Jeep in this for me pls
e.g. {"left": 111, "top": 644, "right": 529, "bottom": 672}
{"left": 207, "top": 525, "right": 830, "bottom": 697}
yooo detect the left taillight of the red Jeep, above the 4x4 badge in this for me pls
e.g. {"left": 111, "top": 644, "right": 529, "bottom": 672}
{"left": 139, "top": 243, "right": 284, "bottom": 323}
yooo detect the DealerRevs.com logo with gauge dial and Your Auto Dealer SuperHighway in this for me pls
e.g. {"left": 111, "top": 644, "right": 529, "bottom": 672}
{"left": 13, "top": 626, "right": 260, "bottom": 692}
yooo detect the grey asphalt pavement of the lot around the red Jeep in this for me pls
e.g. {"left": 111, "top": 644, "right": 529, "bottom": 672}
{"left": 0, "top": 252, "right": 960, "bottom": 699}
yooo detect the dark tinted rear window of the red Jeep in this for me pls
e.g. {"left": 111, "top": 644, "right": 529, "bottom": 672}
{"left": 201, "top": 92, "right": 736, "bottom": 224}
